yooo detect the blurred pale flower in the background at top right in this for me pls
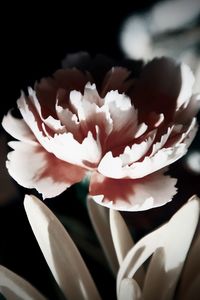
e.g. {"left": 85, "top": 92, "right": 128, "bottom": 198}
{"left": 120, "top": 0, "right": 200, "bottom": 91}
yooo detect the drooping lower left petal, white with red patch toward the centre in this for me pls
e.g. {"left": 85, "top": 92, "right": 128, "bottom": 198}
{"left": 6, "top": 142, "right": 85, "bottom": 198}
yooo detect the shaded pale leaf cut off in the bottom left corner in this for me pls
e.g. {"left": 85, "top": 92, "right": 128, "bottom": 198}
{"left": 0, "top": 266, "right": 46, "bottom": 300}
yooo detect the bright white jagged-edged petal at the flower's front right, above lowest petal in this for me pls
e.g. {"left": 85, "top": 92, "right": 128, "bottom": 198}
{"left": 98, "top": 118, "right": 197, "bottom": 179}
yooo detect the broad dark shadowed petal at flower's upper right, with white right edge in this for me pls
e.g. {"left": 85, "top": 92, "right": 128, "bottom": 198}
{"left": 131, "top": 57, "right": 194, "bottom": 122}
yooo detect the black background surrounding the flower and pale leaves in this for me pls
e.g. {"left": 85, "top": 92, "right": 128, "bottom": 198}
{"left": 0, "top": 1, "right": 200, "bottom": 299}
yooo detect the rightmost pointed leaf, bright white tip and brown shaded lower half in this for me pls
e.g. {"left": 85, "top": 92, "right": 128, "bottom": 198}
{"left": 143, "top": 197, "right": 200, "bottom": 300}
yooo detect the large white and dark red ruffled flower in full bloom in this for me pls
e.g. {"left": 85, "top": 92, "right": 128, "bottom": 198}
{"left": 2, "top": 53, "right": 200, "bottom": 211}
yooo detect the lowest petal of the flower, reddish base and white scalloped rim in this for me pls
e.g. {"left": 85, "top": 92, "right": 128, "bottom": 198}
{"left": 90, "top": 169, "right": 177, "bottom": 211}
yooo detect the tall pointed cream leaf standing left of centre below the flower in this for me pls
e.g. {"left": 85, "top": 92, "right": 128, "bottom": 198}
{"left": 24, "top": 195, "right": 100, "bottom": 300}
